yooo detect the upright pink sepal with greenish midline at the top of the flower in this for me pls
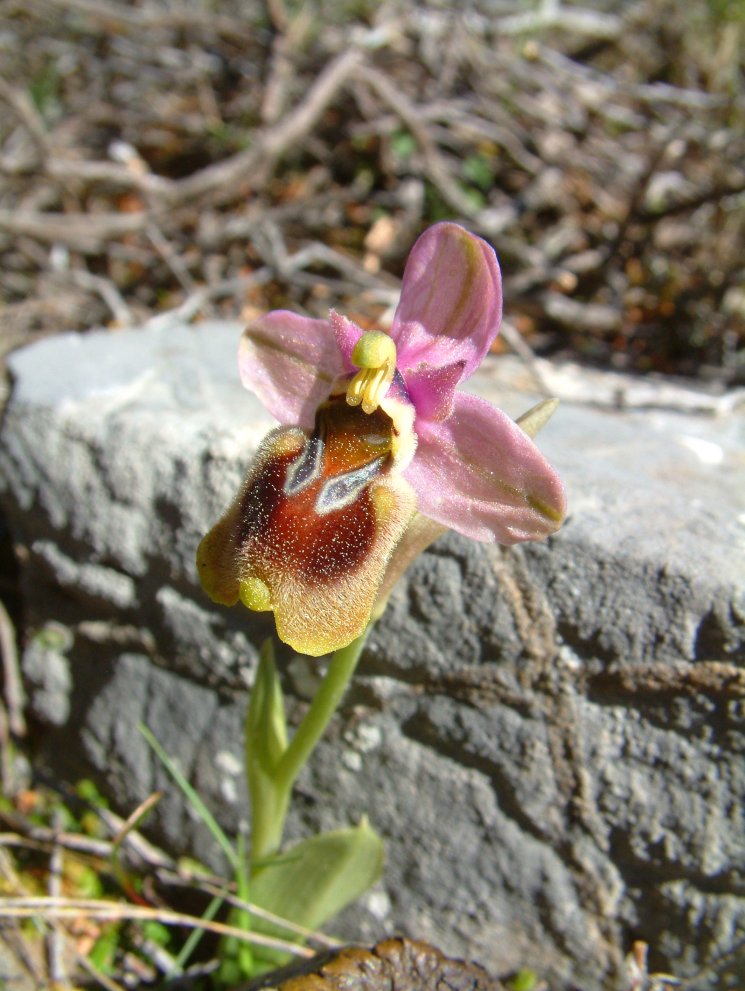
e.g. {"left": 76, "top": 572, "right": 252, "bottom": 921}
{"left": 391, "top": 223, "right": 502, "bottom": 379}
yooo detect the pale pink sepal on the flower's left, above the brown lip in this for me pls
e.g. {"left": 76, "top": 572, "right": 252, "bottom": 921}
{"left": 238, "top": 310, "right": 345, "bottom": 429}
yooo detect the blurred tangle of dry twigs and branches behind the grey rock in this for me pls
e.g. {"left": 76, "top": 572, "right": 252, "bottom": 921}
{"left": 0, "top": 0, "right": 745, "bottom": 389}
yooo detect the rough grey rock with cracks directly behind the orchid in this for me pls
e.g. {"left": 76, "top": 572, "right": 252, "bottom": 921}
{"left": 0, "top": 323, "right": 745, "bottom": 991}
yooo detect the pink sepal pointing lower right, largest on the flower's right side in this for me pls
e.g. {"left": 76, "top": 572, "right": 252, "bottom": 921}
{"left": 404, "top": 393, "right": 565, "bottom": 544}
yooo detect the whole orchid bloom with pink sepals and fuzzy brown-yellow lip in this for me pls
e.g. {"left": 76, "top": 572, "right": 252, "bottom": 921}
{"left": 197, "top": 223, "right": 565, "bottom": 656}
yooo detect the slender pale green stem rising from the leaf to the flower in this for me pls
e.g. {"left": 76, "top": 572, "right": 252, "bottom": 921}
{"left": 251, "top": 624, "right": 372, "bottom": 867}
